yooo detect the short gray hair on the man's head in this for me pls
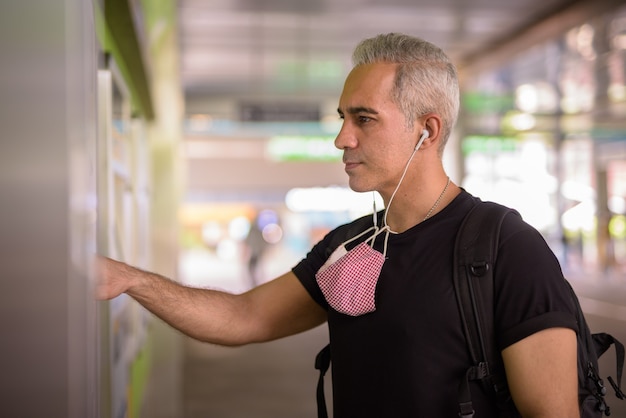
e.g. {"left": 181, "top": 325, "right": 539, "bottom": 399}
{"left": 352, "top": 33, "right": 459, "bottom": 154}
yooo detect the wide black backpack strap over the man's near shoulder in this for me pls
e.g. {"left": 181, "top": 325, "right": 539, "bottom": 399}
{"left": 453, "top": 202, "right": 517, "bottom": 418}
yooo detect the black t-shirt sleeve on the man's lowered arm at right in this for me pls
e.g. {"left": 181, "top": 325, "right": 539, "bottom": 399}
{"left": 495, "top": 215, "right": 578, "bottom": 350}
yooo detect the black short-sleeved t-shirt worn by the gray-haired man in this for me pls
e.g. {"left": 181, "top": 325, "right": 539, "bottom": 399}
{"left": 293, "top": 191, "right": 576, "bottom": 418}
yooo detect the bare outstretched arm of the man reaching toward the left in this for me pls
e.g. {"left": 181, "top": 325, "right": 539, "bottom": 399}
{"left": 96, "top": 257, "right": 326, "bottom": 346}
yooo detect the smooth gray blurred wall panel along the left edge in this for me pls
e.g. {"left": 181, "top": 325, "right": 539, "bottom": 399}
{"left": 0, "top": 0, "right": 99, "bottom": 418}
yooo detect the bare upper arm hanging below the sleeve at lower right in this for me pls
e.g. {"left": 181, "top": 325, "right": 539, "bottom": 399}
{"left": 502, "top": 328, "right": 580, "bottom": 418}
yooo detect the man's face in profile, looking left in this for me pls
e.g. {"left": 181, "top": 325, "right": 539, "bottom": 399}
{"left": 335, "top": 63, "right": 420, "bottom": 198}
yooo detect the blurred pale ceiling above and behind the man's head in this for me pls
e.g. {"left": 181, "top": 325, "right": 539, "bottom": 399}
{"left": 178, "top": 0, "right": 623, "bottom": 107}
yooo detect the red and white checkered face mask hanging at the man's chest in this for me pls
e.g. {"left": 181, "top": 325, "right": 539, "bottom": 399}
{"left": 315, "top": 227, "right": 389, "bottom": 316}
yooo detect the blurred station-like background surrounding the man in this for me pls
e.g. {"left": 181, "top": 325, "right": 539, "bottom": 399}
{"left": 0, "top": 0, "right": 626, "bottom": 418}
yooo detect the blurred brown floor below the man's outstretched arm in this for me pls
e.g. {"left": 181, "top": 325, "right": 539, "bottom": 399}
{"left": 183, "top": 326, "right": 328, "bottom": 418}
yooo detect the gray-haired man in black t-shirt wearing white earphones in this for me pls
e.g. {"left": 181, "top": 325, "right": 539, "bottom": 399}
{"left": 99, "top": 34, "right": 579, "bottom": 418}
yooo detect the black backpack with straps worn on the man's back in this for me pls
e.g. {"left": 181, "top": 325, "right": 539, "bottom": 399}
{"left": 315, "top": 202, "right": 626, "bottom": 418}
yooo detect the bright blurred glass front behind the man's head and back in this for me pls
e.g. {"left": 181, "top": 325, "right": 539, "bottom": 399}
{"left": 461, "top": 7, "right": 626, "bottom": 274}
